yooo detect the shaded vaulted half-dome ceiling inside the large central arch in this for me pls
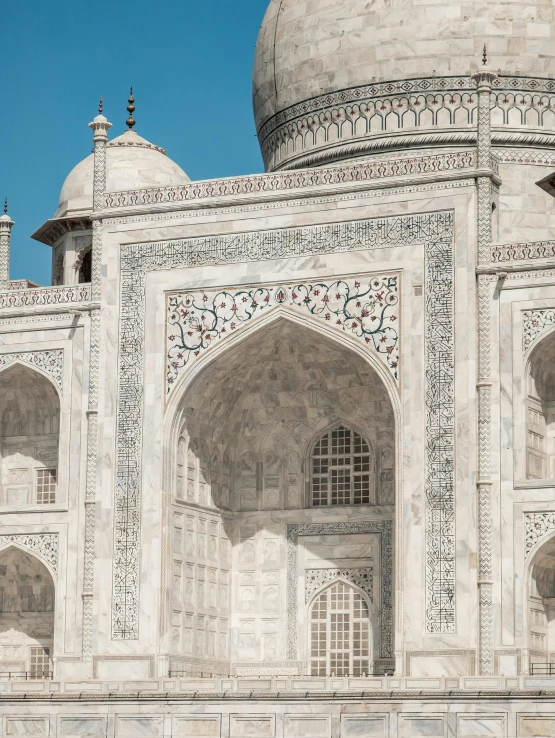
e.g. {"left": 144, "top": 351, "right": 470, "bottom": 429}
{"left": 178, "top": 320, "right": 394, "bottom": 455}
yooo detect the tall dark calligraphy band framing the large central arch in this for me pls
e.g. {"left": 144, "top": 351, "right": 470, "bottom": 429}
{"left": 112, "top": 210, "right": 455, "bottom": 640}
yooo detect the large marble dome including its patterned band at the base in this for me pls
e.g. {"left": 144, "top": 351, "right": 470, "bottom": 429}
{"left": 253, "top": 0, "right": 555, "bottom": 171}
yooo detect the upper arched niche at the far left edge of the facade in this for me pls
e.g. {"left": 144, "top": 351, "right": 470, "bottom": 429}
{"left": 0, "top": 363, "right": 60, "bottom": 507}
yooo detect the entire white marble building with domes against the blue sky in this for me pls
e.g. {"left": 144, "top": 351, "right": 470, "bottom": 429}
{"left": 0, "top": 0, "right": 555, "bottom": 738}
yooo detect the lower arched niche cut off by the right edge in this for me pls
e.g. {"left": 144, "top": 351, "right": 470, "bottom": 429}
{"left": 527, "top": 537, "right": 555, "bottom": 673}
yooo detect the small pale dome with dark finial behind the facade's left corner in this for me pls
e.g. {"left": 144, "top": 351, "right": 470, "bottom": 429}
{"left": 54, "top": 130, "right": 190, "bottom": 218}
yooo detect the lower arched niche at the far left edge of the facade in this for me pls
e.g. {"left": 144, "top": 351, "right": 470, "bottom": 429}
{"left": 0, "top": 546, "right": 55, "bottom": 679}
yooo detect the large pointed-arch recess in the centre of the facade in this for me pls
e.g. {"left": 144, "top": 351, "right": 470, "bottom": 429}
{"left": 170, "top": 319, "right": 395, "bottom": 674}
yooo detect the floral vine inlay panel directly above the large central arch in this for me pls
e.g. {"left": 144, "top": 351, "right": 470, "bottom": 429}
{"left": 166, "top": 274, "right": 399, "bottom": 393}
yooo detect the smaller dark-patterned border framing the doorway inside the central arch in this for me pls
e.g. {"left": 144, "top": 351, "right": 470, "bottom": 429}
{"left": 286, "top": 520, "right": 394, "bottom": 661}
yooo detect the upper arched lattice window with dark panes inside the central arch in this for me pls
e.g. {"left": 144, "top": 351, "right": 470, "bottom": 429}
{"left": 312, "top": 425, "right": 375, "bottom": 507}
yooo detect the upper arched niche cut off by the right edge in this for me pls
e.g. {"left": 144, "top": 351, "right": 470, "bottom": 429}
{"left": 526, "top": 332, "right": 555, "bottom": 479}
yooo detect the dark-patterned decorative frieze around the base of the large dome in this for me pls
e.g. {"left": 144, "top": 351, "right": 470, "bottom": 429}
{"left": 258, "top": 77, "right": 555, "bottom": 171}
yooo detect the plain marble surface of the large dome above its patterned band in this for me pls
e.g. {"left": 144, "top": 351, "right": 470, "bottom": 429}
{"left": 253, "top": 0, "right": 555, "bottom": 169}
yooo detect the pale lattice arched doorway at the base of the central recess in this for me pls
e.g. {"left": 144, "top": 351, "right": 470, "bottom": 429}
{"left": 310, "top": 582, "right": 370, "bottom": 676}
